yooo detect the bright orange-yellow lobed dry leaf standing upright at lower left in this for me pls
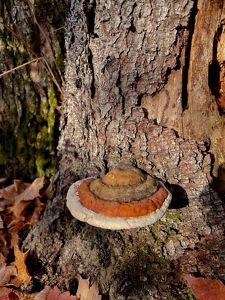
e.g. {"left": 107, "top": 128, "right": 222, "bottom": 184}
{"left": 10, "top": 246, "right": 31, "bottom": 287}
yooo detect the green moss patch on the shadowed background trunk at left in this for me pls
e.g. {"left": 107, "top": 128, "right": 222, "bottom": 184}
{"left": 0, "top": 85, "right": 57, "bottom": 179}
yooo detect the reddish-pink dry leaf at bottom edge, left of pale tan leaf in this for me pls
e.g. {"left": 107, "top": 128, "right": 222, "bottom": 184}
{"left": 35, "top": 286, "right": 76, "bottom": 300}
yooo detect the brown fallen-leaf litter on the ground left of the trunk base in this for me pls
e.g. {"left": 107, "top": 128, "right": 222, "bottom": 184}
{"left": 0, "top": 177, "right": 101, "bottom": 300}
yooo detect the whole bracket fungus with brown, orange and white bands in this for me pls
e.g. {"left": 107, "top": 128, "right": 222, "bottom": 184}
{"left": 67, "top": 168, "right": 172, "bottom": 230}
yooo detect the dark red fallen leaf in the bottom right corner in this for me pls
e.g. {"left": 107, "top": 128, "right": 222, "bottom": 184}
{"left": 182, "top": 274, "right": 225, "bottom": 300}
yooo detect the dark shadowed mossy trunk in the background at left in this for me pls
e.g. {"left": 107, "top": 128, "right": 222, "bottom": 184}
{"left": 0, "top": 0, "right": 66, "bottom": 180}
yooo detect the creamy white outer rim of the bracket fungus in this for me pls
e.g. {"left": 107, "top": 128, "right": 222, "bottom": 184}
{"left": 66, "top": 178, "right": 172, "bottom": 230}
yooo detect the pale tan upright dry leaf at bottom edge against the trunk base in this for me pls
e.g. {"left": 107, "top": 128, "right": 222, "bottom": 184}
{"left": 76, "top": 276, "right": 102, "bottom": 300}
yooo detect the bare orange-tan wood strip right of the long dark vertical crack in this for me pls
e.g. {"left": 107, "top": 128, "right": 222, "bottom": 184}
{"left": 184, "top": 0, "right": 225, "bottom": 140}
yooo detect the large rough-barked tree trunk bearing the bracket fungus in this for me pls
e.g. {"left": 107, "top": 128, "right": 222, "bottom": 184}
{"left": 24, "top": 0, "right": 225, "bottom": 300}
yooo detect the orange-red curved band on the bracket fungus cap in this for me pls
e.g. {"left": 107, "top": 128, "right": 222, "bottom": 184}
{"left": 78, "top": 179, "right": 168, "bottom": 217}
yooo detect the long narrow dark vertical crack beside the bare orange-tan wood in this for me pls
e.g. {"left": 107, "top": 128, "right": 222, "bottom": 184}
{"left": 181, "top": 1, "right": 198, "bottom": 111}
